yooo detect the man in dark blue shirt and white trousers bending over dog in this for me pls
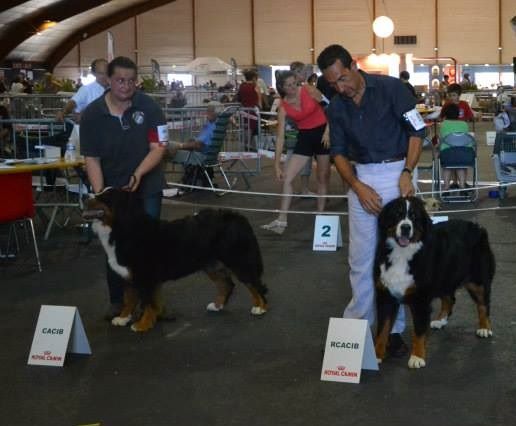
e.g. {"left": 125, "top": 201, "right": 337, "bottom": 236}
{"left": 317, "top": 45, "right": 423, "bottom": 356}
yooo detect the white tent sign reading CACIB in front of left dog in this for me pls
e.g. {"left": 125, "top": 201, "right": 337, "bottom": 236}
{"left": 27, "top": 305, "right": 91, "bottom": 367}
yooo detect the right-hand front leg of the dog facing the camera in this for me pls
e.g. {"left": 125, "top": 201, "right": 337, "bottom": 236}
{"left": 408, "top": 300, "right": 431, "bottom": 368}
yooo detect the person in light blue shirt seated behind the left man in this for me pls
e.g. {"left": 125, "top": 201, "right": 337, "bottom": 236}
{"left": 169, "top": 103, "right": 218, "bottom": 166}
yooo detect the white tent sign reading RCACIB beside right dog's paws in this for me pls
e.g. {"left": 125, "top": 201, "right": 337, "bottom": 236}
{"left": 321, "top": 318, "right": 378, "bottom": 383}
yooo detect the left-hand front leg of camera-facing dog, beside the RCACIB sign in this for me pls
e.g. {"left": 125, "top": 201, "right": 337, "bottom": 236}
{"left": 374, "top": 285, "right": 399, "bottom": 363}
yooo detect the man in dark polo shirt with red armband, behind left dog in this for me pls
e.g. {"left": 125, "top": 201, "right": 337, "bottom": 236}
{"left": 80, "top": 56, "right": 168, "bottom": 319}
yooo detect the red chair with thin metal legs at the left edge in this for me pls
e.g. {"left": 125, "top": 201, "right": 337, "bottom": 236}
{"left": 0, "top": 173, "right": 42, "bottom": 272}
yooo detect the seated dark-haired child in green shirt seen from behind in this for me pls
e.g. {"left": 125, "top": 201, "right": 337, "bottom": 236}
{"left": 439, "top": 103, "right": 474, "bottom": 195}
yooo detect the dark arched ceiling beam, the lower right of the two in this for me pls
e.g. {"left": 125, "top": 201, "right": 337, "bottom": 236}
{"left": 43, "top": 0, "right": 175, "bottom": 70}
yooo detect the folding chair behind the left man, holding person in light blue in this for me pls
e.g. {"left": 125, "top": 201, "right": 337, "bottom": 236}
{"left": 172, "top": 107, "right": 235, "bottom": 193}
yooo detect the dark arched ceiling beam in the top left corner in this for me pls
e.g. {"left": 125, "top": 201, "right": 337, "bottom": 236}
{"left": 0, "top": 0, "right": 109, "bottom": 62}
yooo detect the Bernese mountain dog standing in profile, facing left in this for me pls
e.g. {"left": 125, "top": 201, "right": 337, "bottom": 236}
{"left": 83, "top": 188, "right": 267, "bottom": 331}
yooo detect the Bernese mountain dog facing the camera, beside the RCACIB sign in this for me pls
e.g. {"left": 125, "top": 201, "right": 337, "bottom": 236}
{"left": 374, "top": 197, "right": 495, "bottom": 368}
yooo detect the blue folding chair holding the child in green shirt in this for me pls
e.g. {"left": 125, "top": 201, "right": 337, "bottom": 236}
{"left": 432, "top": 133, "right": 478, "bottom": 202}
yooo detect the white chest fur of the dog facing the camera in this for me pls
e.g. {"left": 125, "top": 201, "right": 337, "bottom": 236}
{"left": 380, "top": 239, "right": 423, "bottom": 299}
